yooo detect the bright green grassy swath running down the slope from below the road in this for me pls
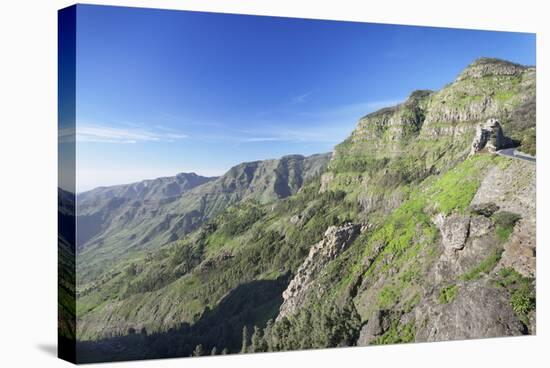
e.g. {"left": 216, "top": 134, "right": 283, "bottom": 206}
{"left": 344, "top": 155, "right": 500, "bottom": 317}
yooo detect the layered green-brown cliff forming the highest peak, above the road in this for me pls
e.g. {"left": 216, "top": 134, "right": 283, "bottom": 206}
{"left": 321, "top": 58, "right": 535, "bottom": 227}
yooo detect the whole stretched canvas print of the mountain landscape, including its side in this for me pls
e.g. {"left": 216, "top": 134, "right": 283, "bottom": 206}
{"left": 58, "top": 5, "right": 536, "bottom": 363}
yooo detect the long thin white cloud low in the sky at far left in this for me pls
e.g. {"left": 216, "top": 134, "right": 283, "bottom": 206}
{"left": 59, "top": 123, "right": 188, "bottom": 144}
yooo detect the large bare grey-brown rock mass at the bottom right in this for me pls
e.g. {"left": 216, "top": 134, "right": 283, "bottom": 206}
{"left": 416, "top": 280, "right": 525, "bottom": 342}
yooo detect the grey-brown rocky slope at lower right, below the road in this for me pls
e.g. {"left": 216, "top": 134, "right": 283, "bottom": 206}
{"left": 358, "top": 160, "right": 535, "bottom": 345}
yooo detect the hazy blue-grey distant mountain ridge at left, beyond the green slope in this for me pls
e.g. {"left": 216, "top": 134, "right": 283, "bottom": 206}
{"left": 77, "top": 153, "right": 331, "bottom": 282}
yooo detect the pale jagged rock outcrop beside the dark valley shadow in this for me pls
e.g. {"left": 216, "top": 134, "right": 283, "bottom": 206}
{"left": 277, "top": 223, "right": 361, "bottom": 320}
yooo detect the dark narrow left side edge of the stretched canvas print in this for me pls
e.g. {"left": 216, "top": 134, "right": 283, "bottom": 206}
{"left": 57, "top": 6, "right": 76, "bottom": 363}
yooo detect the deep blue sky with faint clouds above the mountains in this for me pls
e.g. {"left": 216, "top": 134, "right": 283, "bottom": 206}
{"left": 71, "top": 5, "right": 535, "bottom": 191}
